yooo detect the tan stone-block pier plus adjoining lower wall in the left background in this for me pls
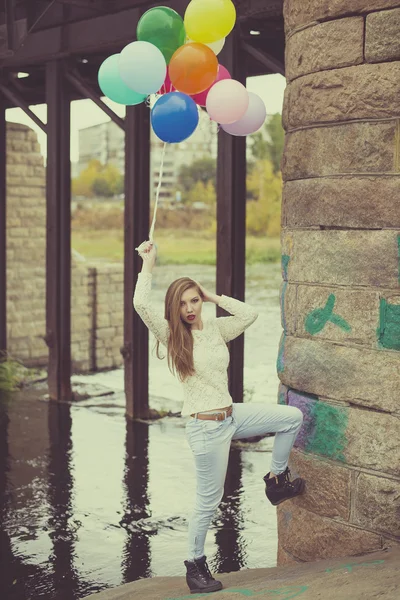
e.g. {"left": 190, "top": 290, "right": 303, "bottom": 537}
{"left": 7, "top": 123, "right": 123, "bottom": 372}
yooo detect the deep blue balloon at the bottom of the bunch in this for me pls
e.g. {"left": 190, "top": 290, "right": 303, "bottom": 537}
{"left": 151, "top": 92, "right": 199, "bottom": 144}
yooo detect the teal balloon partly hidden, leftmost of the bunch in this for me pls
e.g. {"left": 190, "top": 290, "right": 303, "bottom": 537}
{"left": 98, "top": 54, "right": 147, "bottom": 106}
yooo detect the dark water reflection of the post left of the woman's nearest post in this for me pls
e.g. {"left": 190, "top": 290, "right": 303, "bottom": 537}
{"left": 47, "top": 402, "right": 79, "bottom": 600}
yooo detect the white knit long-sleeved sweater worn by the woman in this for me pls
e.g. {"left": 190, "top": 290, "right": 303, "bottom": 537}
{"left": 133, "top": 273, "right": 258, "bottom": 416}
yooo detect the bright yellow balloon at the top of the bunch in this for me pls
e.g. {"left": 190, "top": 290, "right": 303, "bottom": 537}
{"left": 184, "top": 0, "right": 236, "bottom": 44}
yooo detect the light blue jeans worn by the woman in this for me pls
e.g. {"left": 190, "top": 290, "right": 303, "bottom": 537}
{"left": 186, "top": 403, "right": 303, "bottom": 560}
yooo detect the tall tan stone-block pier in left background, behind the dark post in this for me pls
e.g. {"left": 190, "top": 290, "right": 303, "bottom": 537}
{"left": 7, "top": 123, "right": 92, "bottom": 371}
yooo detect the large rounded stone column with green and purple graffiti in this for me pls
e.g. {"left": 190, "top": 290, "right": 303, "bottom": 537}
{"left": 277, "top": 0, "right": 400, "bottom": 564}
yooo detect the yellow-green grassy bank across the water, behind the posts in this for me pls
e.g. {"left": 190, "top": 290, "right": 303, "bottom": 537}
{"left": 72, "top": 230, "right": 280, "bottom": 265}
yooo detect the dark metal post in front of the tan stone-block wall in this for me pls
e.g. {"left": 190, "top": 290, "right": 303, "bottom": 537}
{"left": 46, "top": 61, "right": 72, "bottom": 400}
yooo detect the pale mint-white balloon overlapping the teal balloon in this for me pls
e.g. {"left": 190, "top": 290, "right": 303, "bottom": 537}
{"left": 119, "top": 42, "right": 167, "bottom": 94}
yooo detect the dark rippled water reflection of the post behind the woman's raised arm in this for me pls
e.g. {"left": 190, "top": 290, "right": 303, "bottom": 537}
{"left": 121, "top": 419, "right": 150, "bottom": 583}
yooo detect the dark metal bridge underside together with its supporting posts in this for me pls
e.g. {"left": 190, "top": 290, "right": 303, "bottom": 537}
{"left": 0, "top": 0, "right": 285, "bottom": 418}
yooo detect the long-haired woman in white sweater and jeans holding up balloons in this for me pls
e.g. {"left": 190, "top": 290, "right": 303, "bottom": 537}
{"left": 133, "top": 242, "right": 304, "bottom": 593}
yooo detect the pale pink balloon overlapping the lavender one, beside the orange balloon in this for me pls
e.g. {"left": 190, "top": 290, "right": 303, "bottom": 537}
{"left": 206, "top": 79, "right": 249, "bottom": 125}
